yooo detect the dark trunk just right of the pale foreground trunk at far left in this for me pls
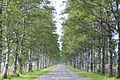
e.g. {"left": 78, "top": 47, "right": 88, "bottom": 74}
{"left": 13, "top": 32, "right": 18, "bottom": 73}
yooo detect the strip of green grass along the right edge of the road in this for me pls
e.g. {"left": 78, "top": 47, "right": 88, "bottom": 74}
{"left": 68, "top": 66, "right": 120, "bottom": 80}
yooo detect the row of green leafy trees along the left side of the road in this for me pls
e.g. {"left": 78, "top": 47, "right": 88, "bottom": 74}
{"left": 0, "top": 0, "right": 60, "bottom": 78}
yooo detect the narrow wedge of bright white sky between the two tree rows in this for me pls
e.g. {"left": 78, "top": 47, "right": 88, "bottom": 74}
{"left": 49, "top": 0, "right": 67, "bottom": 50}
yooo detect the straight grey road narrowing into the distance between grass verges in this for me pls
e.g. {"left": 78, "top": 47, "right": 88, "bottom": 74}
{"left": 33, "top": 65, "right": 89, "bottom": 80}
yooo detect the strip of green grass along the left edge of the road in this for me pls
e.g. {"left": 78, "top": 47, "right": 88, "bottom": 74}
{"left": 2, "top": 66, "right": 55, "bottom": 80}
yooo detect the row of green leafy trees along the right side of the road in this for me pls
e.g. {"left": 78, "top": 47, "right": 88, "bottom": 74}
{"left": 62, "top": 0, "right": 120, "bottom": 78}
